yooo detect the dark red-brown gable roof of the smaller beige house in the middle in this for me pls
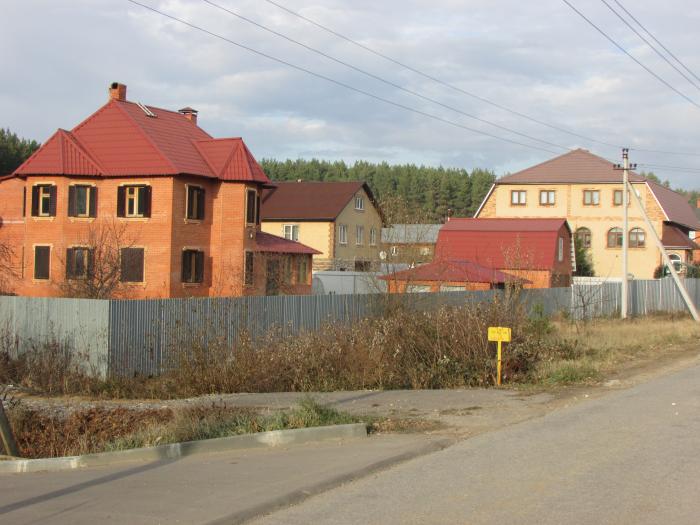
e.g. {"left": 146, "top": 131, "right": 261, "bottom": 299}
{"left": 260, "top": 181, "right": 374, "bottom": 221}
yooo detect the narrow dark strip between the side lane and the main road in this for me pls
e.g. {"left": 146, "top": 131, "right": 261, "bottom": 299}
{"left": 206, "top": 439, "right": 456, "bottom": 525}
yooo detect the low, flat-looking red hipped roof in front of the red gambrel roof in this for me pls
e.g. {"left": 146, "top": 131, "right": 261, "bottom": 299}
{"left": 380, "top": 261, "right": 530, "bottom": 283}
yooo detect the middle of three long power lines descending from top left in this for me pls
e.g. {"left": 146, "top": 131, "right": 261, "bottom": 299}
{"left": 202, "top": 0, "right": 571, "bottom": 150}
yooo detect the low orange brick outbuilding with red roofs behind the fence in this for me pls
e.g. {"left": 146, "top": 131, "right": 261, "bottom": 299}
{"left": 383, "top": 218, "right": 573, "bottom": 293}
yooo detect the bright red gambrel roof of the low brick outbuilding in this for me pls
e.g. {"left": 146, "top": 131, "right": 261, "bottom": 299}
{"left": 435, "top": 218, "right": 571, "bottom": 270}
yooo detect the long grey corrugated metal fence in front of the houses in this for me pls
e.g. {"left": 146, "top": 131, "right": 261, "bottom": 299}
{"left": 0, "top": 279, "right": 700, "bottom": 375}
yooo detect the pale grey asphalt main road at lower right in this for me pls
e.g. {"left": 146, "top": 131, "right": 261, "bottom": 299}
{"left": 255, "top": 365, "right": 700, "bottom": 525}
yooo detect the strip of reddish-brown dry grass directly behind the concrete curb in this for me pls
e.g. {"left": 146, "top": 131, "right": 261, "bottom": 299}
{"left": 8, "top": 399, "right": 366, "bottom": 458}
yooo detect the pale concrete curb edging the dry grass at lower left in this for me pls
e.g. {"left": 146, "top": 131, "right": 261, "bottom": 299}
{"left": 0, "top": 423, "right": 367, "bottom": 474}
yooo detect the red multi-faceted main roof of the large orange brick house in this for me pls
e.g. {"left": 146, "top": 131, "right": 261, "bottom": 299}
{"left": 13, "top": 99, "right": 270, "bottom": 184}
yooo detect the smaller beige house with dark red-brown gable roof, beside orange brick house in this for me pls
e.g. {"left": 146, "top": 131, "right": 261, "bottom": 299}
{"left": 261, "top": 181, "right": 382, "bottom": 271}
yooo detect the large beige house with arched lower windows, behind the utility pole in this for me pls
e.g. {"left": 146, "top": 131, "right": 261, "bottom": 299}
{"left": 475, "top": 149, "right": 700, "bottom": 279}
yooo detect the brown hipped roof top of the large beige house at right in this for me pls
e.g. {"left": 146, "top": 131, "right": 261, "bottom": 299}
{"left": 496, "top": 149, "right": 646, "bottom": 184}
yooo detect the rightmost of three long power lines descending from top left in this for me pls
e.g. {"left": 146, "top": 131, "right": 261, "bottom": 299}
{"left": 265, "top": 0, "right": 621, "bottom": 149}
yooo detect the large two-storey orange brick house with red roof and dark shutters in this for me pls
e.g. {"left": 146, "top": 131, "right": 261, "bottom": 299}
{"left": 0, "top": 83, "right": 317, "bottom": 298}
